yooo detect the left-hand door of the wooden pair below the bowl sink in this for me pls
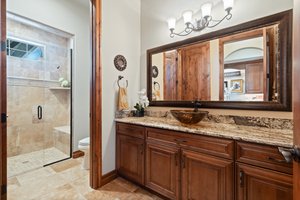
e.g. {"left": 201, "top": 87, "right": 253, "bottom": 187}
{"left": 146, "top": 143, "right": 180, "bottom": 199}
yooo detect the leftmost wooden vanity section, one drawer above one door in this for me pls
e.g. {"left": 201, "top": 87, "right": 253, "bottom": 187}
{"left": 116, "top": 123, "right": 145, "bottom": 185}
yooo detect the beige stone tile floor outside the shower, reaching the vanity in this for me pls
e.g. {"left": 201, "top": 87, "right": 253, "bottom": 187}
{"left": 8, "top": 158, "right": 160, "bottom": 200}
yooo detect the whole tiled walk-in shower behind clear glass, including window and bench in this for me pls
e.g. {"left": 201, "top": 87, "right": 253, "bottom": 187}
{"left": 6, "top": 13, "right": 73, "bottom": 177}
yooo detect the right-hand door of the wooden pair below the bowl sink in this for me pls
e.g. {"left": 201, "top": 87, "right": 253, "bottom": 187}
{"left": 181, "top": 150, "right": 234, "bottom": 200}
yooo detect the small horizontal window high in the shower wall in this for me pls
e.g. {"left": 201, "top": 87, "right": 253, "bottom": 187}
{"left": 6, "top": 38, "right": 45, "bottom": 60}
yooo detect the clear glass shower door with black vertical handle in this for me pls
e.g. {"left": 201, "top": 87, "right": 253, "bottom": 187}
{"left": 7, "top": 34, "right": 46, "bottom": 177}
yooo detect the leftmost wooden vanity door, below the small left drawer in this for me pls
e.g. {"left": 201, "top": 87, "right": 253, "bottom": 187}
{"left": 117, "top": 134, "right": 144, "bottom": 184}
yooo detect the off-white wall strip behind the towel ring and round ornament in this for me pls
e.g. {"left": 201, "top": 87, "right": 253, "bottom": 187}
{"left": 102, "top": 0, "right": 141, "bottom": 174}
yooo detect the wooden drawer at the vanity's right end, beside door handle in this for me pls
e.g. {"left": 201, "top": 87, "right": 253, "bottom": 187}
{"left": 236, "top": 142, "right": 293, "bottom": 174}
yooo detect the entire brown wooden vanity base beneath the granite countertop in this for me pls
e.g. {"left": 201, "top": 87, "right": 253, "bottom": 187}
{"left": 117, "top": 123, "right": 293, "bottom": 200}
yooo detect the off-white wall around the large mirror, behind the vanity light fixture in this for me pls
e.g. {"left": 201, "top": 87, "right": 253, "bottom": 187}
{"left": 141, "top": 0, "right": 293, "bottom": 118}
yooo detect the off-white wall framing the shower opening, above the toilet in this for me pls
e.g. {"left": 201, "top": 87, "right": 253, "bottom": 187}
{"left": 7, "top": 0, "right": 91, "bottom": 150}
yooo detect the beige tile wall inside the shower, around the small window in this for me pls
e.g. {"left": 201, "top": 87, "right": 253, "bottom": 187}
{"left": 7, "top": 19, "right": 70, "bottom": 157}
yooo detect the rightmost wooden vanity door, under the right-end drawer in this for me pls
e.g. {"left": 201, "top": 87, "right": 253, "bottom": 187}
{"left": 236, "top": 164, "right": 293, "bottom": 200}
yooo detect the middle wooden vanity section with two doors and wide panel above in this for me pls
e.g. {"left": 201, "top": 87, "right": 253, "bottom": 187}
{"left": 146, "top": 128, "right": 234, "bottom": 200}
